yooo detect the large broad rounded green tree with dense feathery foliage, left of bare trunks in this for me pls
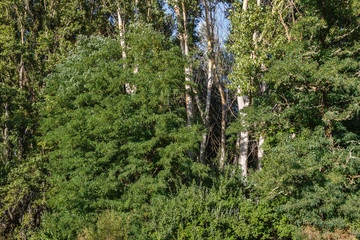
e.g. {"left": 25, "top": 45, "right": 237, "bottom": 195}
{"left": 42, "top": 24, "right": 202, "bottom": 239}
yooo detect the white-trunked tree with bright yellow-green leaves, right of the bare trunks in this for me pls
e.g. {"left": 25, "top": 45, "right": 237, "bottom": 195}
{"left": 229, "top": 0, "right": 295, "bottom": 177}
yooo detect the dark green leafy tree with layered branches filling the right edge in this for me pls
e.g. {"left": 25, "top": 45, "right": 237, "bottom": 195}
{"left": 232, "top": 1, "right": 360, "bottom": 238}
